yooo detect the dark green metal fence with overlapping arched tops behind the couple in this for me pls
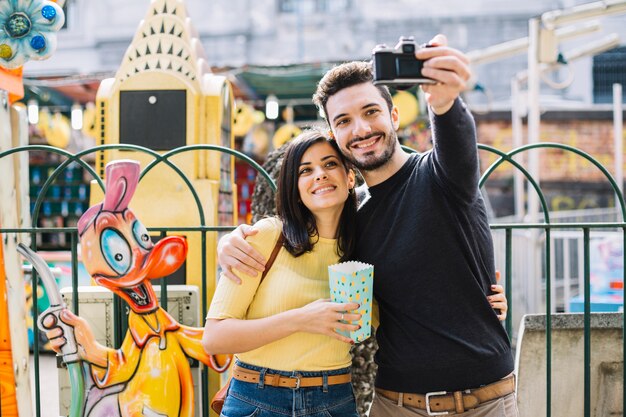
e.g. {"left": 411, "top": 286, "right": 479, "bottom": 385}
{"left": 0, "top": 142, "right": 626, "bottom": 417}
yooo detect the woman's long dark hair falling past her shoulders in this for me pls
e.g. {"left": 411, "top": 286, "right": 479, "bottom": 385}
{"left": 276, "top": 130, "right": 356, "bottom": 262}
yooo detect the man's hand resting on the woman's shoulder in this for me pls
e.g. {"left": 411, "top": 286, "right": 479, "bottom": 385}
{"left": 217, "top": 224, "right": 267, "bottom": 284}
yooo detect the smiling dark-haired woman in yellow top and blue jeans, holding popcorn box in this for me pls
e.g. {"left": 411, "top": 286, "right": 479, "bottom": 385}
{"left": 203, "top": 131, "right": 506, "bottom": 417}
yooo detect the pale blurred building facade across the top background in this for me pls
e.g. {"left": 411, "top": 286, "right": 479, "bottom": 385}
{"left": 26, "top": 0, "right": 626, "bottom": 105}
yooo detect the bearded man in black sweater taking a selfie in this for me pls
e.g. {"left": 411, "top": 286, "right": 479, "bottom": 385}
{"left": 220, "top": 35, "right": 517, "bottom": 417}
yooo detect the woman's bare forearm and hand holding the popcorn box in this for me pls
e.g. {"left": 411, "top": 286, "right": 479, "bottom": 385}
{"left": 202, "top": 299, "right": 361, "bottom": 354}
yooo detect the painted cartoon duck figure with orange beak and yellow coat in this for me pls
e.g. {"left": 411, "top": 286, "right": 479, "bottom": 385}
{"left": 42, "top": 160, "right": 231, "bottom": 417}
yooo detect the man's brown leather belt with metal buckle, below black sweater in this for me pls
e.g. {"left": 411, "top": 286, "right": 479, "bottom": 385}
{"left": 376, "top": 375, "right": 515, "bottom": 416}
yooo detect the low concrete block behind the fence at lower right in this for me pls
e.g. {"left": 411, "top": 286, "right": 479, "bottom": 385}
{"left": 516, "top": 313, "right": 624, "bottom": 417}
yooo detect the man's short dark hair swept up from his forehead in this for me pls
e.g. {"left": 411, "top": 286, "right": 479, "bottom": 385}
{"left": 313, "top": 61, "right": 393, "bottom": 122}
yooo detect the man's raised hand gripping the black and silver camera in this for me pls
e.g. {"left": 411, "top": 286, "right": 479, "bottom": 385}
{"left": 415, "top": 34, "right": 471, "bottom": 115}
